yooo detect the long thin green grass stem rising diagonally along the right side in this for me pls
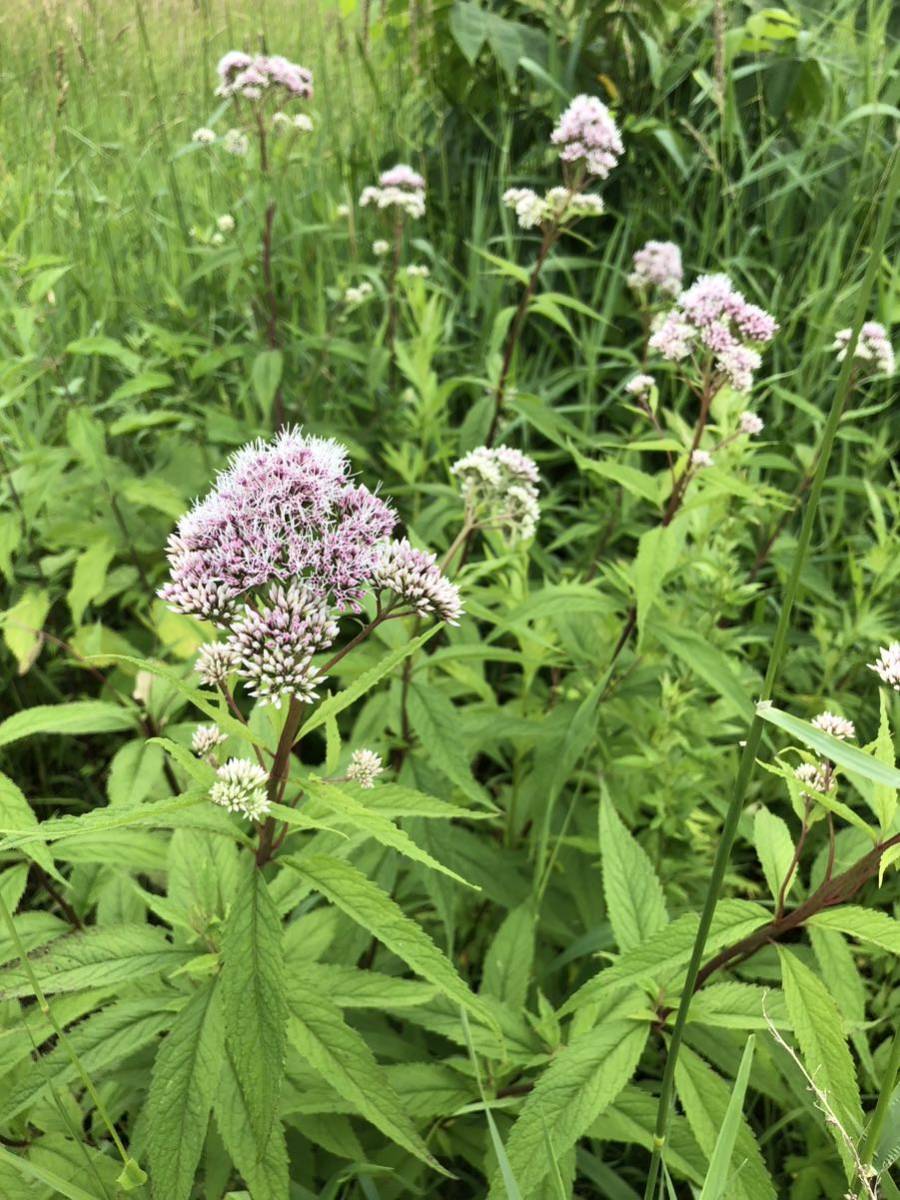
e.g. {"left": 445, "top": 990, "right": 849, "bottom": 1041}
{"left": 644, "top": 146, "right": 900, "bottom": 1200}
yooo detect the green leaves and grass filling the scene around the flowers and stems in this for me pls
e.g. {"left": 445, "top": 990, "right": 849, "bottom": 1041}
{"left": 0, "top": 0, "right": 900, "bottom": 1200}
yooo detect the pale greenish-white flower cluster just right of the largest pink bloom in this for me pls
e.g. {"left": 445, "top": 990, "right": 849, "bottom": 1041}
{"left": 450, "top": 446, "right": 540, "bottom": 541}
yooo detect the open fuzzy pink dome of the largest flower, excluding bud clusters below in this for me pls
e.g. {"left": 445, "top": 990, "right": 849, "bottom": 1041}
{"left": 160, "top": 428, "right": 396, "bottom": 628}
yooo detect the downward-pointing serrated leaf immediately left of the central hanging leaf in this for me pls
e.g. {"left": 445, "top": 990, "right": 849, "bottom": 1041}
{"left": 146, "top": 982, "right": 224, "bottom": 1200}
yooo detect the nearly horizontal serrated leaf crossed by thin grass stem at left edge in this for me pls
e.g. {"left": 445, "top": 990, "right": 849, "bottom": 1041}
{"left": 0, "top": 925, "right": 193, "bottom": 1000}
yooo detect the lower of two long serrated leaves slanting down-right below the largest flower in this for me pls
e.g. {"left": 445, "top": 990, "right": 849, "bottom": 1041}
{"left": 288, "top": 972, "right": 443, "bottom": 1170}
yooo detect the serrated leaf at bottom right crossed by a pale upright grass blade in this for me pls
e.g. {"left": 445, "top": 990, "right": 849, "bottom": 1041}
{"left": 676, "top": 1045, "right": 775, "bottom": 1200}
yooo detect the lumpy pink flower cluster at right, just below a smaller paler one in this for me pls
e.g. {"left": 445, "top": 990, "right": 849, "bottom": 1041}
{"left": 649, "top": 275, "right": 778, "bottom": 391}
